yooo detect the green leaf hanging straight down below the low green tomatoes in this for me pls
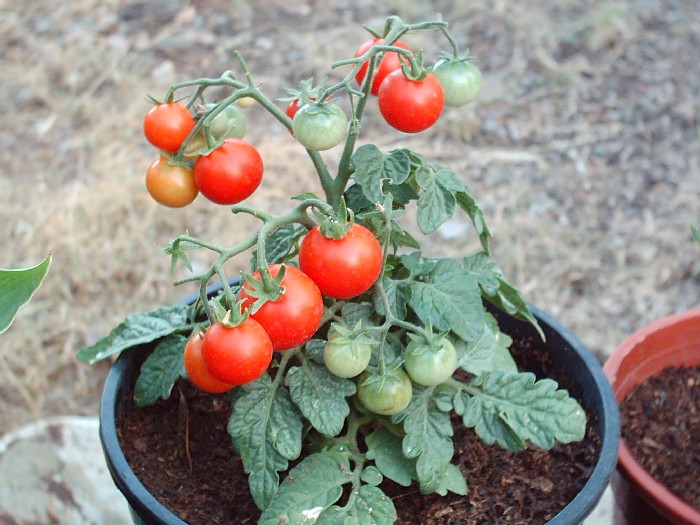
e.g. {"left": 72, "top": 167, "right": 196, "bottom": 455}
{"left": 397, "top": 386, "right": 454, "bottom": 493}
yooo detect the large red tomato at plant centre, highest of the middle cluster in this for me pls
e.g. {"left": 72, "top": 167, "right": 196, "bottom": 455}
{"left": 299, "top": 224, "right": 383, "bottom": 299}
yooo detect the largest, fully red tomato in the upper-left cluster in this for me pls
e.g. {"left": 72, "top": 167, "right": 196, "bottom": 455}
{"left": 194, "top": 138, "right": 263, "bottom": 205}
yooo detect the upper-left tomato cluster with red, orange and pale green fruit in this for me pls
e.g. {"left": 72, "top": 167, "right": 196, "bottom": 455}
{"left": 143, "top": 102, "right": 263, "bottom": 208}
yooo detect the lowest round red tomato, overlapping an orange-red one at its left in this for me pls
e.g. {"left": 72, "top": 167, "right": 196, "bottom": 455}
{"left": 202, "top": 318, "right": 272, "bottom": 385}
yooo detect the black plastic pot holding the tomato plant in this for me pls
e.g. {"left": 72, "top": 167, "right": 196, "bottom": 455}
{"left": 100, "top": 299, "right": 620, "bottom": 525}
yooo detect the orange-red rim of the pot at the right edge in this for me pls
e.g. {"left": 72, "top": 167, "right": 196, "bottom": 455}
{"left": 603, "top": 307, "right": 700, "bottom": 525}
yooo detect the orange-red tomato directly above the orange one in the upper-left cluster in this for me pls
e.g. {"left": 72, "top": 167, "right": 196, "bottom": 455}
{"left": 143, "top": 102, "right": 194, "bottom": 153}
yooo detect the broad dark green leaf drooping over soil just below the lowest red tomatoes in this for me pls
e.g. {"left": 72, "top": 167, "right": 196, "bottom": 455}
{"left": 228, "top": 374, "right": 302, "bottom": 510}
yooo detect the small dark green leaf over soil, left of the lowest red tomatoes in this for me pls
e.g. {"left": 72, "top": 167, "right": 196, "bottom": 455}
{"left": 134, "top": 335, "right": 187, "bottom": 407}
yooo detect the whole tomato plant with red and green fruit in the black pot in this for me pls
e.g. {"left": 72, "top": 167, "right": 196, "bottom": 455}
{"left": 79, "top": 17, "right": 586, "bottom": 525}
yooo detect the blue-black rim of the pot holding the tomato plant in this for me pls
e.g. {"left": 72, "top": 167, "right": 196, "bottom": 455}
{"left": 100, "top": 294, "right": 620, "bottom": 525}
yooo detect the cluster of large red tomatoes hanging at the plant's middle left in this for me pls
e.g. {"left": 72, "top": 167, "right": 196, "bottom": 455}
{"left": 185, "top": 224, "right": 382, "bottom": 392}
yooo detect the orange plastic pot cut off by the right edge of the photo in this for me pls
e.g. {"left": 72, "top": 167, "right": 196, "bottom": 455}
{"left": 603, "top": 308, "right": 700, "bottom": 525}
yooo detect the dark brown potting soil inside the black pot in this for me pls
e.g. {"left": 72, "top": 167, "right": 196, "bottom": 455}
{"left": 118, "top": 334, "right": 600, "bottom": 525}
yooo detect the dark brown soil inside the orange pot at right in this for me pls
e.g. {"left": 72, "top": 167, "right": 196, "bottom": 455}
{"left": 620, "top": 366, "right": 700, "bottom": 510}
